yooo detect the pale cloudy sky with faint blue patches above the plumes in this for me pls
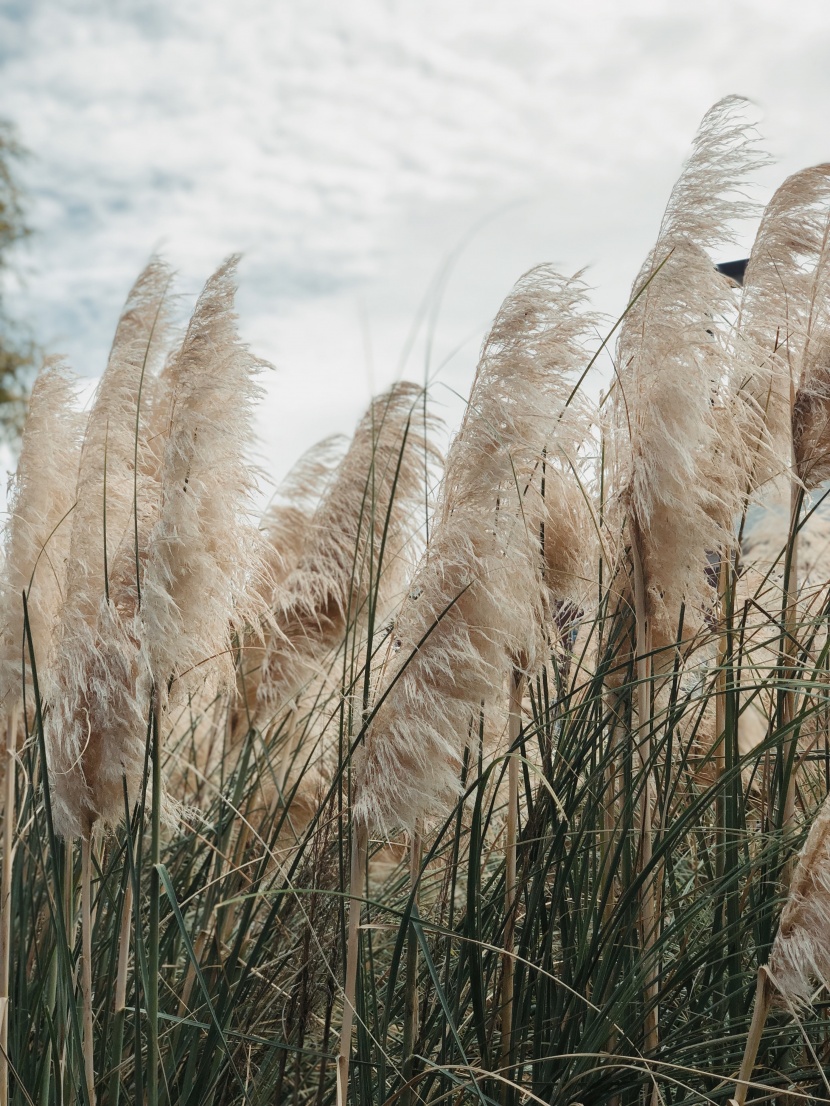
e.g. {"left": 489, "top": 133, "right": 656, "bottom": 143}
{"left": 0, "top": 0, "right": 830, "bottom": 493}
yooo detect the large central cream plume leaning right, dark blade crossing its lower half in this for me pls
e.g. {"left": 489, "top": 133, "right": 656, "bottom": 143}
{"left": 354, "top": 267, "right": 593, "bottom": 832}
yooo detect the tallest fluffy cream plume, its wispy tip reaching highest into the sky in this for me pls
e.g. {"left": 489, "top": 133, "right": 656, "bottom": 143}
{"left": 615, "top": 97, "right": 759, "bottom": 635}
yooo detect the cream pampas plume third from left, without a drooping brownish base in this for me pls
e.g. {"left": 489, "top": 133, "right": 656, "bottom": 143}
{"left": 141, "top": 258, "right": 263, "bottom": 702}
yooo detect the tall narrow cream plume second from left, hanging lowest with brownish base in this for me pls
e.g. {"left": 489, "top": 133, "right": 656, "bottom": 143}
{"left": 45, "top": 260, "right": 170, "bottom": 837}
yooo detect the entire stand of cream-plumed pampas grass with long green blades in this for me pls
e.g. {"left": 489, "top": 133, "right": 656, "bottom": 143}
{"left": 11, "top": 90, "right": 830, "bottom": 1106}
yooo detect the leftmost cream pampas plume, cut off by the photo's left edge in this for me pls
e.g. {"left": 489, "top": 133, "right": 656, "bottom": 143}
{"left": 0, "top": 358, "right": 83, "bottom": 714}
